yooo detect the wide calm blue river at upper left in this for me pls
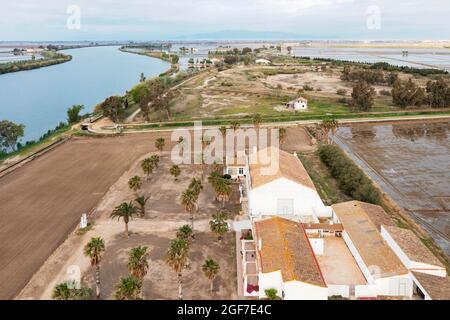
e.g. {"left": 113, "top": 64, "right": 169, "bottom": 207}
{"left": 0, "top": 47, "right": 170, "bottom": 142}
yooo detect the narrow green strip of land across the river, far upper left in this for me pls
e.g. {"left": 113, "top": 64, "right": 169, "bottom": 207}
{"left": 0, "top": 51, "right": 72, "bottom": 75}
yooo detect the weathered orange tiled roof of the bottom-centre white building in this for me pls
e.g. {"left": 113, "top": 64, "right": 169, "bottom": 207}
{"left": 255, "top": 217, "right": 326, "bottom": 287}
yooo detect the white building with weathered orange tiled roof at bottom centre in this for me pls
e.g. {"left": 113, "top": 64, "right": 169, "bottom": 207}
{"left": 253, "top": 217, "right": 328, "bottom": 300}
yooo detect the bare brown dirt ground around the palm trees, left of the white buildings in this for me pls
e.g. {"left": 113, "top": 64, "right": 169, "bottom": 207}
{"left": 18, "top": 154, "right": 238, "bottom": 299}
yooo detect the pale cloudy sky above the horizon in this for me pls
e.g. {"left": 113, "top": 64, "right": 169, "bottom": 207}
{"left": 0, "top": 0, "right": 450, "bottom": 41}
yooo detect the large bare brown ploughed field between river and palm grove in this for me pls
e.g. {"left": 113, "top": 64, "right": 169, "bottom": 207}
{"left": 0, "top": 133, "right": 170, "bottom": 299}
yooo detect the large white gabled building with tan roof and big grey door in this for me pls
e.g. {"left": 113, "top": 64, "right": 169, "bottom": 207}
{"left": 248, "top": 147, "right": 331, "bottom": 223}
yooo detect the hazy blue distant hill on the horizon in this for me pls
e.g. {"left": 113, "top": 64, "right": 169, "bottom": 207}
{"left": 175, "top": 30, "right": 304, "bottom": 40}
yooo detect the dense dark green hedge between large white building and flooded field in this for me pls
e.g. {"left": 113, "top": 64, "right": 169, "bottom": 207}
{"left": 318, "top": 145, "right": 381, "bottom": 204}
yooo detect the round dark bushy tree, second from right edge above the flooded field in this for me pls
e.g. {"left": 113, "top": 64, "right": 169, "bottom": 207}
{"left": 391, "top": 79, "right": 426, "bottom": 109}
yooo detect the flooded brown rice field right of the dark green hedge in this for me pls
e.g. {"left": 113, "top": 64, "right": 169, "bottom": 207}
{"left": 335, "top": 121, "right": 450, "bottom": 255}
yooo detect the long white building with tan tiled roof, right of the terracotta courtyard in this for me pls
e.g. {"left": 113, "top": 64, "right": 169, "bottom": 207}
{"left": 332, "top": 201, "right": 413, "bottom": 298}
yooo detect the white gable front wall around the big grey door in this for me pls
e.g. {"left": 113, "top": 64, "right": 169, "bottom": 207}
{"left": 249, "top": 178, "right": 325, "bottom": 217}
